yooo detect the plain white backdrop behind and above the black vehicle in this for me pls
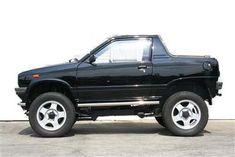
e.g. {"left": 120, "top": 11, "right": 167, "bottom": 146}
{"left": 0, "top": 0, "right": 235, "bottom": 120}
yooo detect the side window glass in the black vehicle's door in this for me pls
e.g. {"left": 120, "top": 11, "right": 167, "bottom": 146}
{"left": 95, "top": 39, "right": 151, "bottom": 63}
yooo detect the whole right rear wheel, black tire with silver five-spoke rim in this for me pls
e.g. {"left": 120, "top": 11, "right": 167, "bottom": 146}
{"left": 162, "top": 91, "right": 208, "bottom": 136}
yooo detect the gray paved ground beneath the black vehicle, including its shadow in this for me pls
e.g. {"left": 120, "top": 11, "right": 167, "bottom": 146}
{"left": 0, "top": 120, "right": 235, "bottom": 157}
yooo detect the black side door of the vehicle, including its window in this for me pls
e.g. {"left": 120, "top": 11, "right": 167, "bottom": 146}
{"left": 77, "top": 38, "right": 152, "bottom": 102}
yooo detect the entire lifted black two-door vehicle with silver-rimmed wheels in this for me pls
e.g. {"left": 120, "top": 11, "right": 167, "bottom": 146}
{"left": 15, "top": 35, "right": 222, "bottom": 137}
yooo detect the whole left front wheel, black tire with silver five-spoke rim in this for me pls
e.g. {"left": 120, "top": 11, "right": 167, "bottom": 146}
{"left": 29, "top": 92, "right": 76, "bottom": 137}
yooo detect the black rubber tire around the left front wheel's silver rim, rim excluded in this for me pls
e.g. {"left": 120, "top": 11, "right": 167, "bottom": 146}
{"left": 29, "top": 92, "right": 76, "bottom": 137}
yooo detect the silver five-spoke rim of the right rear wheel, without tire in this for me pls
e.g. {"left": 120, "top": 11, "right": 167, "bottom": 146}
{"left": 171, "top": 100, "right": 201, "bottom": 130}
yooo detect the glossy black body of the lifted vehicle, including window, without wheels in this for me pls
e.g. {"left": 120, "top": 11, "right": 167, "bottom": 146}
{"left": 16, "top": 35, "right": 222, "bottom": 136}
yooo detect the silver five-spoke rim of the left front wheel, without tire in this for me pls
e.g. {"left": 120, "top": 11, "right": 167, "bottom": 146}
{"left": 37, "top": 101, "right": 67, "bottom": 131}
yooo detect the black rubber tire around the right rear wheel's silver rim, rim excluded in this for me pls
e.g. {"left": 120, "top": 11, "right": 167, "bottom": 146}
{"left": 162, "top": 91, "right": 208, "bottom": 136}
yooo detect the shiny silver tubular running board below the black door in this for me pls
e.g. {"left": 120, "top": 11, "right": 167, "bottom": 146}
{"left": 77, "top": 101, "right": 159, "bottom": 107}
